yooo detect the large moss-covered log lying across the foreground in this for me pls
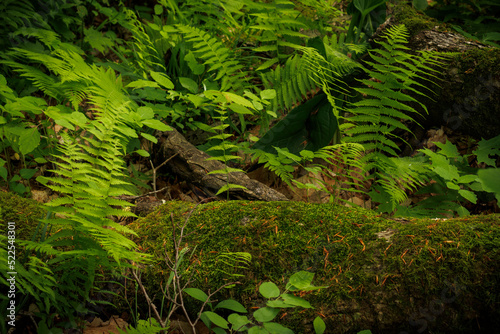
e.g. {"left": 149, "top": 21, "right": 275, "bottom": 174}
{"left": 129, "top": 201, "right": 500, "bottom": 333}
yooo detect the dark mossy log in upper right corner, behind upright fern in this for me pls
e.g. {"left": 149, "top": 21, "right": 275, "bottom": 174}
{"left": 373, "top": 3, "right": 500, "bottom": 139}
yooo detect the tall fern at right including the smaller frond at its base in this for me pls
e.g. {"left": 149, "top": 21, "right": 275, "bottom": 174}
{"left": 343, "top": 25, "right": 446, "bottom": 206}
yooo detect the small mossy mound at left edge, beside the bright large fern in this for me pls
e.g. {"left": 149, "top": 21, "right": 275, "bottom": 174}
{"left": 0, "top": 191, "right": 46, "bottom": 240}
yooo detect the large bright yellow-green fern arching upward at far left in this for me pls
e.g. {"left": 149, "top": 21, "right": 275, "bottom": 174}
{"left": 0, "top": 42, "right": 169, "bottom": 326}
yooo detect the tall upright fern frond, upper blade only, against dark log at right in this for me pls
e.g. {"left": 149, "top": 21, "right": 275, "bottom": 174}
{"left": 345, "top": 25, "right": 442, "bottom": 156}
